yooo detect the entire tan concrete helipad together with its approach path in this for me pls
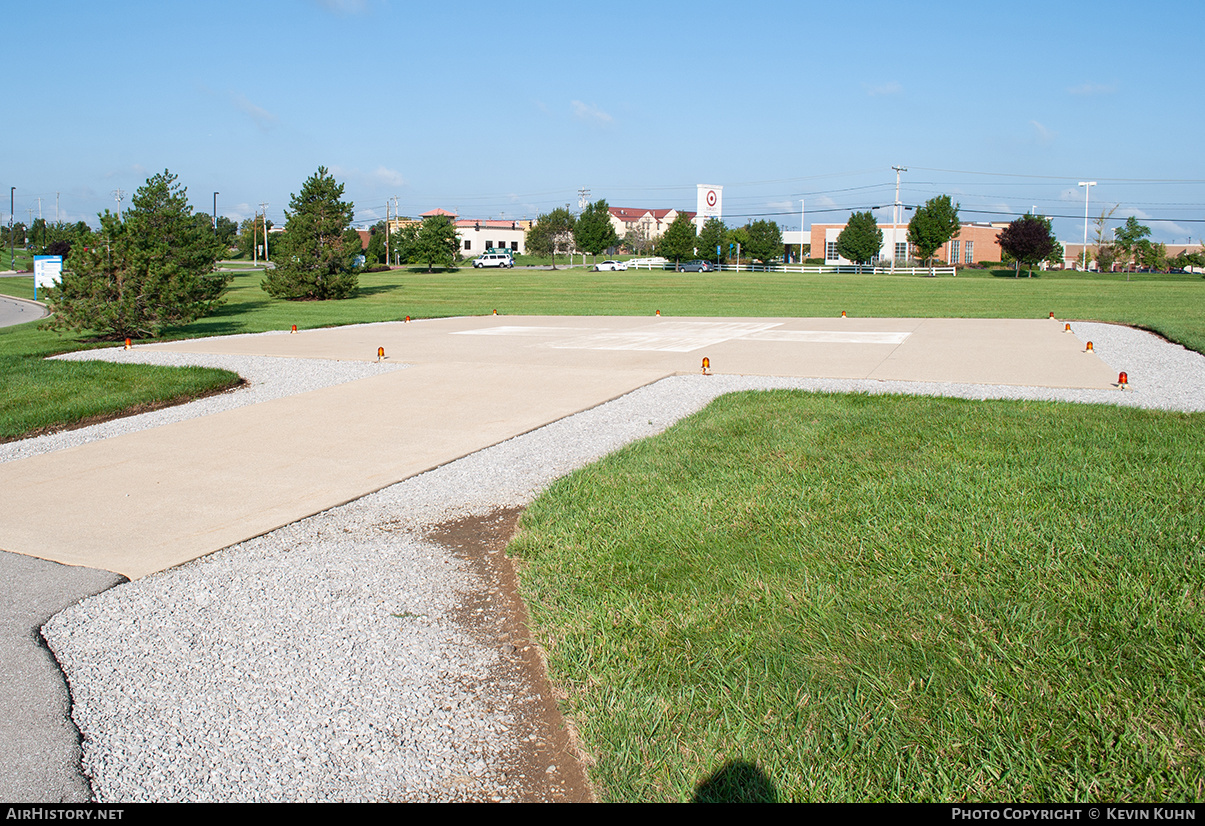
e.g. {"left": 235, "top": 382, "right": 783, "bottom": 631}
{"left": 0, "top": 316, "right": 1115, "bottom": 578}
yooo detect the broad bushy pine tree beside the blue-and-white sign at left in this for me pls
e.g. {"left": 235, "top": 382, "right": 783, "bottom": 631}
{"left": 46, "top": 170, "right": 230, "bottom": 339}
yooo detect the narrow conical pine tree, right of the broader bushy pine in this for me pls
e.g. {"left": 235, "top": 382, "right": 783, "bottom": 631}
{"left": 261, "top": 166, "right": 360, "bottom": 300}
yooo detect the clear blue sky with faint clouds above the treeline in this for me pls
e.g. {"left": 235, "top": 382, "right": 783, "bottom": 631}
{"left": 9, "top": 0, "right": 1205, "bottom": 242}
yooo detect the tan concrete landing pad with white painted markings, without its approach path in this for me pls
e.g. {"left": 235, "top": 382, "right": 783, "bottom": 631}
{"left": 138, "top": 316, "right": 1116, "bottom": 387}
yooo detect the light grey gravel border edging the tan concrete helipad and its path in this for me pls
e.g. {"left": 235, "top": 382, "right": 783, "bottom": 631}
{"left": 35, "top": 323, "right": 1205, "bottom": 802}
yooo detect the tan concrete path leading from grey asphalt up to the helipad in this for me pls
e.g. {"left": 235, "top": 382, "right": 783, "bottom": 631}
{"left": 0, "top": 364, "right": 664, "bottom": 579}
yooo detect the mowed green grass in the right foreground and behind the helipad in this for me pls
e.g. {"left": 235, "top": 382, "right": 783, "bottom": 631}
{"left": 0, "top": 270, "right": 1205, "bottom": 801}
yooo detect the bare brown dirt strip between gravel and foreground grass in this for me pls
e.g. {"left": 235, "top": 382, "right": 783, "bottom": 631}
{"left": 427, "top": 508, "right": 595, "bottom": 803}
